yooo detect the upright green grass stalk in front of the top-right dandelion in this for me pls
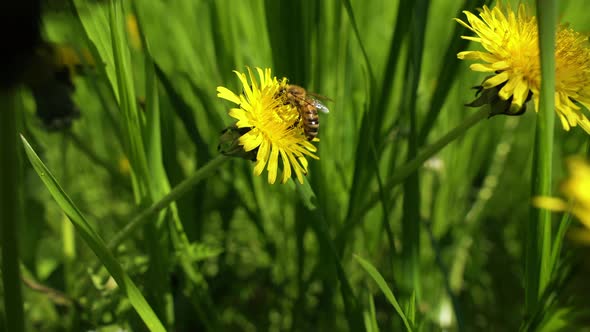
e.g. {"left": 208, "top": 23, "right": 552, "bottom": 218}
{"left": 525, "top": 0, "right": 557, "bottom": 313}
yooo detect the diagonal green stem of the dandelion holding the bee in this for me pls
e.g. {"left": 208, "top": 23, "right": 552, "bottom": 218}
{"left": 108, "top": 155, "right": 229, "bottom": 250}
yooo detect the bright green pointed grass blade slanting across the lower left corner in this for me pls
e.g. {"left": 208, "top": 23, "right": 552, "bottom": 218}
{"left": 21, "top": 136, "right": 166, "bottom": 331}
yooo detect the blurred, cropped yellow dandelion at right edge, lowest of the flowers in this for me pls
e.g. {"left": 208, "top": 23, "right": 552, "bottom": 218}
{"left": 533, "top": 157, "right": 590, "bottom": 228}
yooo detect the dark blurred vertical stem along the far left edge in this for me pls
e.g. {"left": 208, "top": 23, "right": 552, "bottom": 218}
{"left": 0, "top": 90, "right": 25, "bottom": 332}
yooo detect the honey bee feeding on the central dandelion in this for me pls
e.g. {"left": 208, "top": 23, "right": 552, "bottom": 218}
{"left": 284, "top": 84, "right": 330, "bottom": 141}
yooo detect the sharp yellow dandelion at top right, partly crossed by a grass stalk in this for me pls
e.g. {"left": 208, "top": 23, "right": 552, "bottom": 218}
{"left": 455, "top": 4, "right": 590, "bottom": 133}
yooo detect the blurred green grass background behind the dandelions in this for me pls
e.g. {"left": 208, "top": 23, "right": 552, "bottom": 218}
{"left": 4, "top": 0, "right": 590, "bottom": 331}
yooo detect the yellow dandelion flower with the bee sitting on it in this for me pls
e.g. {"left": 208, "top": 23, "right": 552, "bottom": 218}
{"left": 217, "top": 68, "right": 319, "bottom": 184}
